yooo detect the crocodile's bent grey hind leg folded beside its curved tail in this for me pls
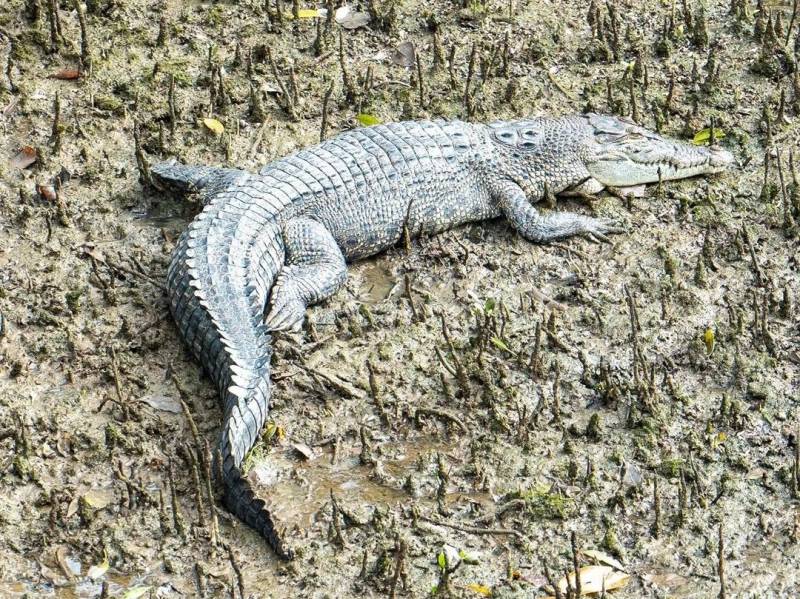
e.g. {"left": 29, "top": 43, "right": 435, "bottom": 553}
{"left": 265, "top": 218, "right": 347, "bottom": 331}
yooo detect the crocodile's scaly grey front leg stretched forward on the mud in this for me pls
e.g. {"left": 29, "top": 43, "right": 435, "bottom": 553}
{"left": 493, "top": 181, "right": 624, "bottom": 243}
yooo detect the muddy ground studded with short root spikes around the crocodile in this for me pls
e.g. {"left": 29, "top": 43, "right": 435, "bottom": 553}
{"left": 0, "top": 0, "right": 800, "bottom": 597}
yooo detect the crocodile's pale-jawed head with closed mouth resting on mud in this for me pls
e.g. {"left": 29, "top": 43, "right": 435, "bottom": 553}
{"left": 579, "top": 114, "right": 733, "bottom": 187}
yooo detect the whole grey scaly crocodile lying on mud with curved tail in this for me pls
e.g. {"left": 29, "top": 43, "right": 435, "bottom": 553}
{"left": 151, "top": 114, "right": 733, "bottom": 559}
